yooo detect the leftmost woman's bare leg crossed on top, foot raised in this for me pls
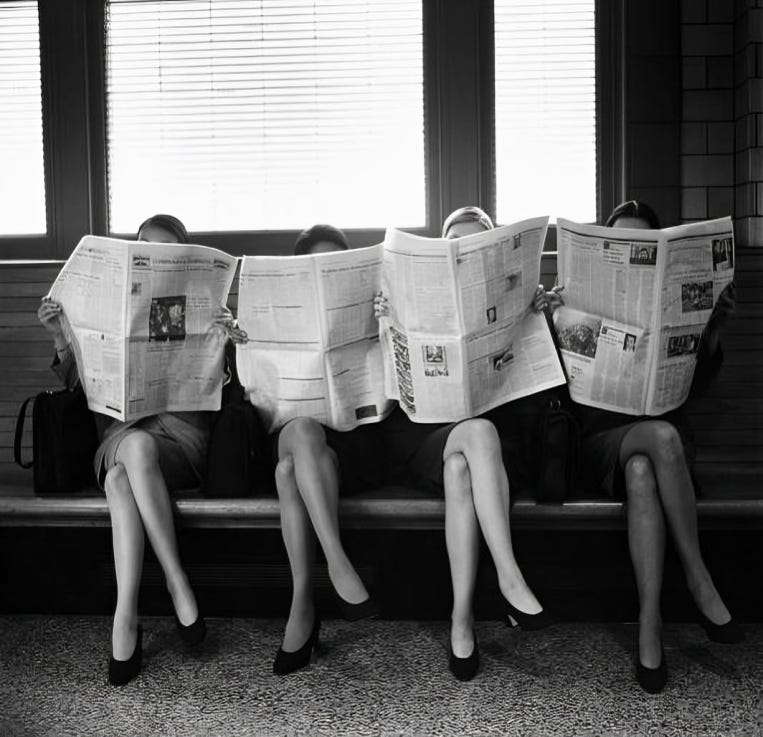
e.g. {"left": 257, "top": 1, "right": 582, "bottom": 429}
{"left": 116, "top": 430, "right": 199, "bottom": 625}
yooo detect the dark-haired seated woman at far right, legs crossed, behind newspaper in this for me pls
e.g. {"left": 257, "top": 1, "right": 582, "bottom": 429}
{"left": 546, "top": 200, "right": 743, "bottom": 693}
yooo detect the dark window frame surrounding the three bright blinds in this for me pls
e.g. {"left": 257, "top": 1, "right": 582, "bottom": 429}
{"left": 0, "top": 0, "right": 627, "bottom": 260}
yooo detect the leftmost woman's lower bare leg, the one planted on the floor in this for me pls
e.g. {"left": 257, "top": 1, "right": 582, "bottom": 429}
{"left": 105, "top": 463, "right": 145, "bottom": 660}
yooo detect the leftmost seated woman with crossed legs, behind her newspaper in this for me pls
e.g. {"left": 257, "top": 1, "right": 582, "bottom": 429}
{"left": 37, "top": 215, "right": 229, "bottom": 686}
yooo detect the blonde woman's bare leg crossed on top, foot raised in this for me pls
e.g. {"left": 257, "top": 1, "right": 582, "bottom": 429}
{"left": 443, "top": 419, "right": 542, "bottom": 614}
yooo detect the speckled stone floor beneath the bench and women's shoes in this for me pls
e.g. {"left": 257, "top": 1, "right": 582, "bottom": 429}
{"left": 0, "top": 616, "right": 763, "bottom": 737}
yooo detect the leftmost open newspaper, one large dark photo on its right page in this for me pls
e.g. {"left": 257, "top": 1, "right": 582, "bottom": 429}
{"left": 50, "top": 236, "right": 236, "bottom": 421}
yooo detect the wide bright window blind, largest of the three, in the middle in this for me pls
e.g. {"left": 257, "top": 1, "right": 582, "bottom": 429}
{"left": 106, "top": 0, "right": 426, "bottom": 232}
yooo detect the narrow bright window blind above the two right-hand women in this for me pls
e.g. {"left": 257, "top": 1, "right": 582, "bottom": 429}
{"left": 495, "top": 0, "right": 596, "bottom": 222}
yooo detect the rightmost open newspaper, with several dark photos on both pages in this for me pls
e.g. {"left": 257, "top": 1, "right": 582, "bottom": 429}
{"left": 554, "top": 218, "right": 734, "bottom": 415}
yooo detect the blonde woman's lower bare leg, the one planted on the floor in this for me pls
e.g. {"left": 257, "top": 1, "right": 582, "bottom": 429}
{"left": 443, "top": 453, "right": 479, "bottom": 658}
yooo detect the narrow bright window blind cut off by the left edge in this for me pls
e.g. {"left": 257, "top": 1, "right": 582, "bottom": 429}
{"left": 0, "top": 1, "right": 47, "bottom": 235}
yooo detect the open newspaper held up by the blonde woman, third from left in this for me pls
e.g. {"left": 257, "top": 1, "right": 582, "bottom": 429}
{"left": 381, "top": 217, "right": 565, "bottom": 422}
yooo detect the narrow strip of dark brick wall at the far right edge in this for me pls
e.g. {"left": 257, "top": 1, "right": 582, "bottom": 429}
{"left": 733, "top": 0, "right": 763, "bottom": 246}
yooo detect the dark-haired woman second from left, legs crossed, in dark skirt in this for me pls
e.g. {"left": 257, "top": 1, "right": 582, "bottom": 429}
{"left": 273, "top": 225, "right": 379, "bottom": 675}
